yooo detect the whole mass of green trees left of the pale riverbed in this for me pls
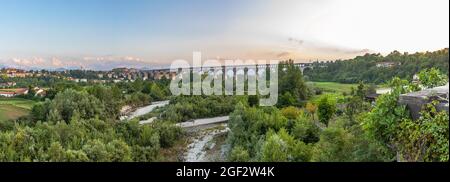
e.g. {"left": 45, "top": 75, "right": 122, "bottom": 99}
{"left": 0, "top": 79, "right": 182, "bottom": 162}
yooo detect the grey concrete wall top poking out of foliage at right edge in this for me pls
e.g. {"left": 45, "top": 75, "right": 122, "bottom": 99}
{"left": 399, "top": 83, "right": 449, "bottom": 120}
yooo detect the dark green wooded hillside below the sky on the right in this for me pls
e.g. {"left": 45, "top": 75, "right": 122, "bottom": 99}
{"left": 304, "top": 48, "right": 449, "bottom": 84}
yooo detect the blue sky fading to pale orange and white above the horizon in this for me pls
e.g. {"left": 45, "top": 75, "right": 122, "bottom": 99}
{"left": 0, "top": 0, "right": 449, "bottom": 69}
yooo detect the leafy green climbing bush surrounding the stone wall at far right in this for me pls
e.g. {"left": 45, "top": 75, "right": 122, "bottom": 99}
{"left": 364, "top": 69, "right": 449, "bottom": 161}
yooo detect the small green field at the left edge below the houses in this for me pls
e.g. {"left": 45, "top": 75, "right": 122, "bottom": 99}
{"left": 0, "top": 98, "right": 36, "bottom": 121}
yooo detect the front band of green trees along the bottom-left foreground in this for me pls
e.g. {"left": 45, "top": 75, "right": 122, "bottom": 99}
{"left": 0, "top": 118, "right": 183, "bottom": 162}
